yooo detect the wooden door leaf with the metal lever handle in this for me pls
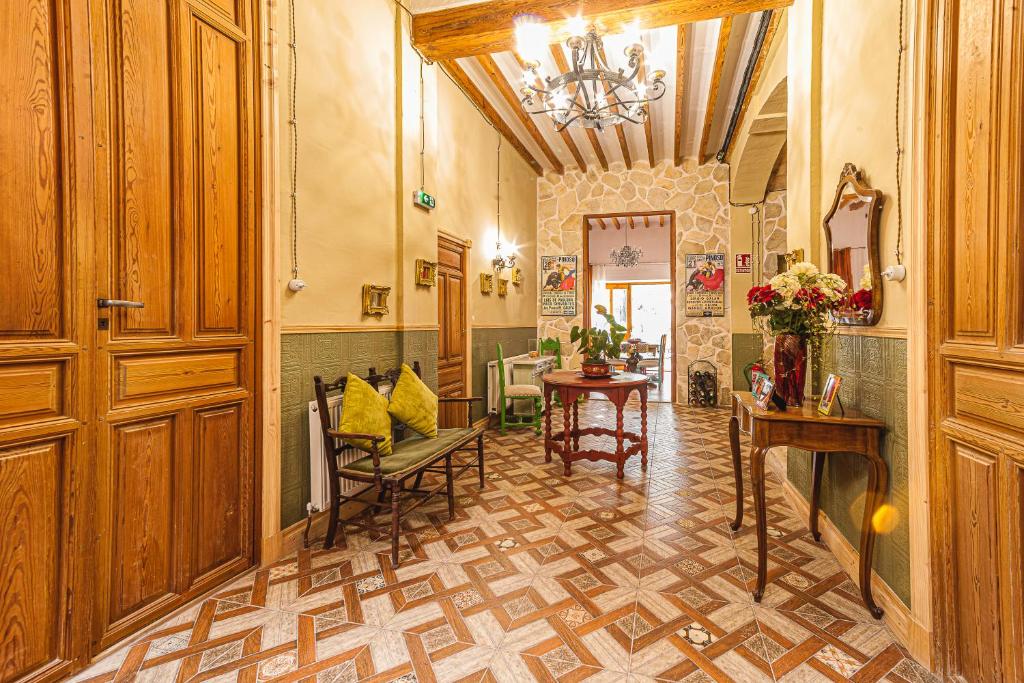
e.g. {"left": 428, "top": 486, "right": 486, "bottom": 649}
{"left": 90, "top": 0, "right": 259, "bottom": 650}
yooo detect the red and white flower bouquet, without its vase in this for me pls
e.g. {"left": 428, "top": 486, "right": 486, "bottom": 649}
{"left": 746, "top": 262, "right": 847, "bottom": 347}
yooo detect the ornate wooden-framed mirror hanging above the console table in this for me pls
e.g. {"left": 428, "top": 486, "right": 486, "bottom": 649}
{"left": 824, "top": 164, "right": 885, "bottom": 326}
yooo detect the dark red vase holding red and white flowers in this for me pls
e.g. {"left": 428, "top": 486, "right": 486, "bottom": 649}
{"left": 746, "top": 262, "right": 847, "bottom": 407}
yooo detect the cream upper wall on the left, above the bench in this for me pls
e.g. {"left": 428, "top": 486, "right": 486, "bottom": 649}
{"left": 278, "top": 0, "right": 537, "bottom": 332}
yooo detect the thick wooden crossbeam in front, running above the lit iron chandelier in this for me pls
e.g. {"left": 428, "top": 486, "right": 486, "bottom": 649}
{"left": 413, "top": 0, "right": 793, "bottom": 59}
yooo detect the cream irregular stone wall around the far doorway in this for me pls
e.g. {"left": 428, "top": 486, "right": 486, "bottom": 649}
{"left": 538, "top": 159, "right": 732, "bottom": 403}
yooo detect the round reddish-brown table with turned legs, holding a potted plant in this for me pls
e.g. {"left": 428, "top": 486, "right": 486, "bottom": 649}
{"left": 544, "top": 370, "right": 648, "bottom": 479}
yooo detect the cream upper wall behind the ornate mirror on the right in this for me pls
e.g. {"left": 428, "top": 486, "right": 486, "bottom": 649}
{"left": 787, "top": 0, "right": 913, "bottom": 330}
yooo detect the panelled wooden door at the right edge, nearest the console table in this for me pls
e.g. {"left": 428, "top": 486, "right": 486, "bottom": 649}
{"left": 929, "top": 0, "right": 1024, "bottom": 681}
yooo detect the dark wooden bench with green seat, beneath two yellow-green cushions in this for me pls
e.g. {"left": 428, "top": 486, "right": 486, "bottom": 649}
{"left": 313, "top": 362, "right": 483, "bottom": 568}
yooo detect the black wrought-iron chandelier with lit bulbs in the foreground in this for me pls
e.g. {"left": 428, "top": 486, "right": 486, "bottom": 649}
{"left": 517, "top": 19, "right": 666, "bottom": 132}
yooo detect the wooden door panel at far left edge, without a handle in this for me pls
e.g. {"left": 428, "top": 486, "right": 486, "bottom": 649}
{"left": 0, "top": 0, "right": 95, "bottom": 682}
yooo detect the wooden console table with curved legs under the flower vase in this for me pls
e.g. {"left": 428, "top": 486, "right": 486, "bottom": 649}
{"left": 729, "top": 391, "right": 889, "bottom": 618}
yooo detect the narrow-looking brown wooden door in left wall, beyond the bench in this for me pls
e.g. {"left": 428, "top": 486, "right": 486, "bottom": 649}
{"left": 437, "top": 238, "right": 468, "bottom": 425}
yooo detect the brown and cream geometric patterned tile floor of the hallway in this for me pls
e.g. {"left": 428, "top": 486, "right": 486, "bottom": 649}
{"left": 72, "top": 401, "right": 931, "bottom": 683}
